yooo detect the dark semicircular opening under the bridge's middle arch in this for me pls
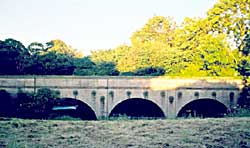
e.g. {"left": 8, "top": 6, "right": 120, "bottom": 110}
{"left": 109, "top": 98, "right": 165, "bottom": 118}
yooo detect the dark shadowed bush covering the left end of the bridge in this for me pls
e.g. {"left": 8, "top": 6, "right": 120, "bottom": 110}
{"left": 0, "top": 88, "right": 59, "bottom": 119}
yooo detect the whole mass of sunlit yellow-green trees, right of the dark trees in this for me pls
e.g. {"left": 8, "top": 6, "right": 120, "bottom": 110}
{"left": 91, "top": 0, "right": 250, "bottom": 76}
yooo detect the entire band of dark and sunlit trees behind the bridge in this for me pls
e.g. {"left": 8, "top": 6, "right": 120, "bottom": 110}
{"left": 0, "top": 0, "right": 250, "bottom": 77}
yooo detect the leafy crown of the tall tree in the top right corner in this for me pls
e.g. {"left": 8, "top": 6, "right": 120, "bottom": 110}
{"left": 207, "top": 0, "right": 250, "bottom": 51}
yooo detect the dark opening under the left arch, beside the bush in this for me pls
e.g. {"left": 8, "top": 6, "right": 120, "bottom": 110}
{"left": 51, "top": 98, "right": 97, "bottom": 120}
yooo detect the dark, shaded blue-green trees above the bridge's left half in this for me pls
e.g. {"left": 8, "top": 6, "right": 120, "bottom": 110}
{"left": 0, "top": 39, "right": 119, "bottom": 75}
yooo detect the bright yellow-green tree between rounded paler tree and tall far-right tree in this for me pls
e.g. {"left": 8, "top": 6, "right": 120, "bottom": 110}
{"left": 175, "top": 18, "right": 238, "bottom": 76}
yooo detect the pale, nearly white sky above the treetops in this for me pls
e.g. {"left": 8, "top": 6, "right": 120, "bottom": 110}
{"left": 0, "top": 0, "right": 217, "bottom": 55}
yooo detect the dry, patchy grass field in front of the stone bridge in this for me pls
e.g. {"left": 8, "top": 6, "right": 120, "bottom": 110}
{"left": 0, "top": 118, "right": 250, "bottom": 148}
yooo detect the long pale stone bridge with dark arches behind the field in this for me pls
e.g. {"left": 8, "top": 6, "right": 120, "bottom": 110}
{"left": 0, "top": 76, "right": 242, "bottom": 118}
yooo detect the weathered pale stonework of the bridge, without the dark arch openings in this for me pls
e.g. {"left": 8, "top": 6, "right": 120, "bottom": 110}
{"left": 0, "top": 76, "right": 242, "bottom": 118}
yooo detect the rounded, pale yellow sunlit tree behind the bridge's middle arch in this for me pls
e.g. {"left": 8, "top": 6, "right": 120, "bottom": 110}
{"left": 111, "top": 16, "right": 176, "bottom": 73}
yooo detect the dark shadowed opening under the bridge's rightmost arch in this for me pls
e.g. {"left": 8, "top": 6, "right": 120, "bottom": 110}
{"left": 177, "top": 99, "right": 227, "bottom": 118}
